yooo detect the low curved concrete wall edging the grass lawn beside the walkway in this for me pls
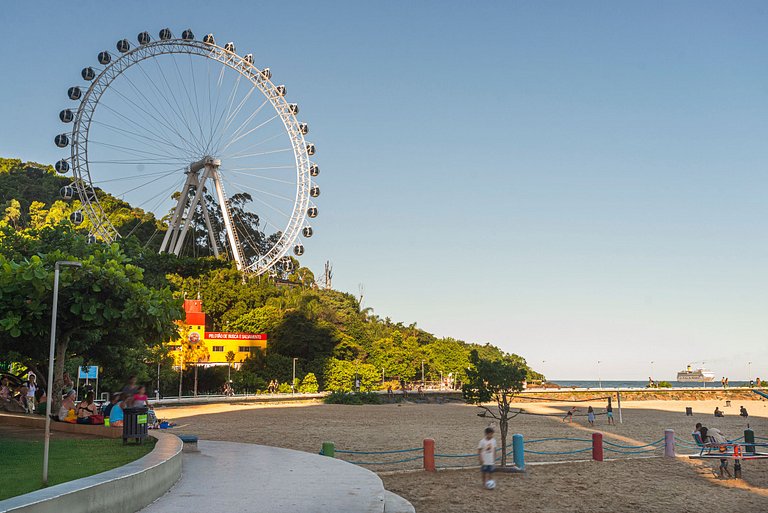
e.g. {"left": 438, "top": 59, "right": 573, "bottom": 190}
{"left": 0, "top": 433, "right": 183, "bottom": 513}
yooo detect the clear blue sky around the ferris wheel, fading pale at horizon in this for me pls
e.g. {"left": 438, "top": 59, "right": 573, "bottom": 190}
{"left": 0, "top": 1, "right": 768, "bottom": 380}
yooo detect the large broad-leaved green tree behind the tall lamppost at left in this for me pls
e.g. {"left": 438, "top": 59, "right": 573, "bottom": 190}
{"left": 0, "top": 227, "right": 183, "bottom": 411}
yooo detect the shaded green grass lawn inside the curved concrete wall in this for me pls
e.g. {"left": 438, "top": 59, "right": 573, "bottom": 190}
{"left": 0, "top": 438, "right": 155, "bottom": 500}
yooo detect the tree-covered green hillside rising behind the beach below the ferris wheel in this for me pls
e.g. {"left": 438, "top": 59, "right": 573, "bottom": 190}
{"left": 0, "top": 159, "right": 541, "bottom": 395}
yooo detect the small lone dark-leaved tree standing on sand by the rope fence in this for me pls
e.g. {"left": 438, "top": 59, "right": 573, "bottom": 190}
{"left": 462, "top": 349, "right": 527, "bottom": 467}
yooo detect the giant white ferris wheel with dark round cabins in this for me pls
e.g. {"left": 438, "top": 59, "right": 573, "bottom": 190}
{"left": 54, "top": 28, "right": 320, "bottom": 274}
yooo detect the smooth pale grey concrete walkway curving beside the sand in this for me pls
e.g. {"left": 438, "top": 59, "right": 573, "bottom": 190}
{"left": 142, "top": 440, "right": 413, "bottom": 513}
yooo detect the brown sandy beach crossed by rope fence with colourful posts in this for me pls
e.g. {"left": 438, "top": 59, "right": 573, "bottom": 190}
{"left": 158, "top": 400, "right": 768, "bottom": 513}
